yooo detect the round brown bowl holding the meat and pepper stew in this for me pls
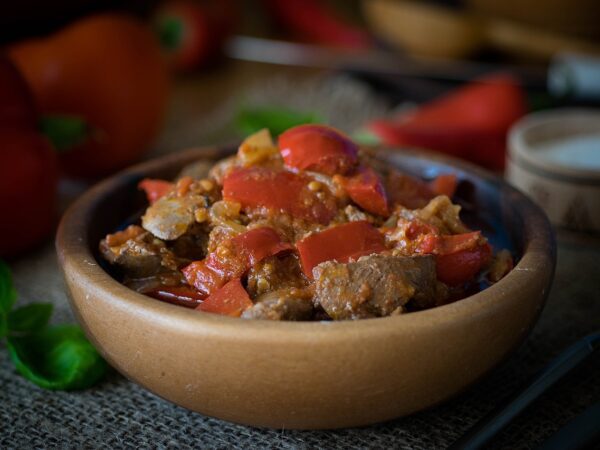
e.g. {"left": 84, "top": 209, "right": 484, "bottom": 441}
{"left": 56, "top": 150, "right": 555, "bottom": 429}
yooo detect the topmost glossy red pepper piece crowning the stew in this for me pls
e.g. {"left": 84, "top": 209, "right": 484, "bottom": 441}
{"left": 279, "top": 124, "right": 358, "bottom": 175}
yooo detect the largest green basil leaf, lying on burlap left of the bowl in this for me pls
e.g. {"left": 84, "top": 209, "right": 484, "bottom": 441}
{"left": 8, "top": 325, "right": 107, "bottom": 390}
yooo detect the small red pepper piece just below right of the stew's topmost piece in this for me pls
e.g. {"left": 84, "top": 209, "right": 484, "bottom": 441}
{"left": 342, "top": 167, "right": 390, "bottom": 217}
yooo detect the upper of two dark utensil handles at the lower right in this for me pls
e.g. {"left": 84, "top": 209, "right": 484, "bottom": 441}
{"left": 450, "top": 332, "right": 600, "bottom": 450}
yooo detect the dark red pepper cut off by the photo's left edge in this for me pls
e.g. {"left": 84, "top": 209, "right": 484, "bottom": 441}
{"left": 0, "top": 55, "right": 58, "bottom": 257}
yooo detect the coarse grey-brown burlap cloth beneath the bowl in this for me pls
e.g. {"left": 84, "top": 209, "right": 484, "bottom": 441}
{"left": 0, "top": 73, "right": 600, "bottom": 449}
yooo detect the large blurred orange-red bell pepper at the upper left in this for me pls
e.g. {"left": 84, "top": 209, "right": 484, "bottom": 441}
{"left": 9, "top": 14, "right": 168, "bottom": 177}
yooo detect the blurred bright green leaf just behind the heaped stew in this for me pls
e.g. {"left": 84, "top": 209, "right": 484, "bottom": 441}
{"left": 235, "top": 107, "right": 323, "bottom": 136}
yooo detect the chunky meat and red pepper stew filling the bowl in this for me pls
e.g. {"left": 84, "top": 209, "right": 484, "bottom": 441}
{"left": 100, "top": 125, "right": 512, "bottom": 320}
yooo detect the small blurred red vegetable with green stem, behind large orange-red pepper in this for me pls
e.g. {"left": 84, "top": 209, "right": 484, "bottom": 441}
{"left": 153, "top": 0, "right": 239, "bottom": 72}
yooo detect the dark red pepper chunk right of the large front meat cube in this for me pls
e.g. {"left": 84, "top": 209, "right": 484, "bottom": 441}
{"left": 435, "top": 243, "right": 492, "bottom": 286}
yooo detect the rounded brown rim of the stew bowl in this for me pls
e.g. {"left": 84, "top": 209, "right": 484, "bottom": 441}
{"left": 56, "top": 147, "right": 556, "bottom": 341}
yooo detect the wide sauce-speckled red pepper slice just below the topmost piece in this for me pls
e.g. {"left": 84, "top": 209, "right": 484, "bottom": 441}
{"left": 223, "top": 167, "right": 337, "bottom": 225}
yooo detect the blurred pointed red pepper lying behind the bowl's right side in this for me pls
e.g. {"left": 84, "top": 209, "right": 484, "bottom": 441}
{"left": 368, "top": 76, "right": 527, "bottom": 170}
